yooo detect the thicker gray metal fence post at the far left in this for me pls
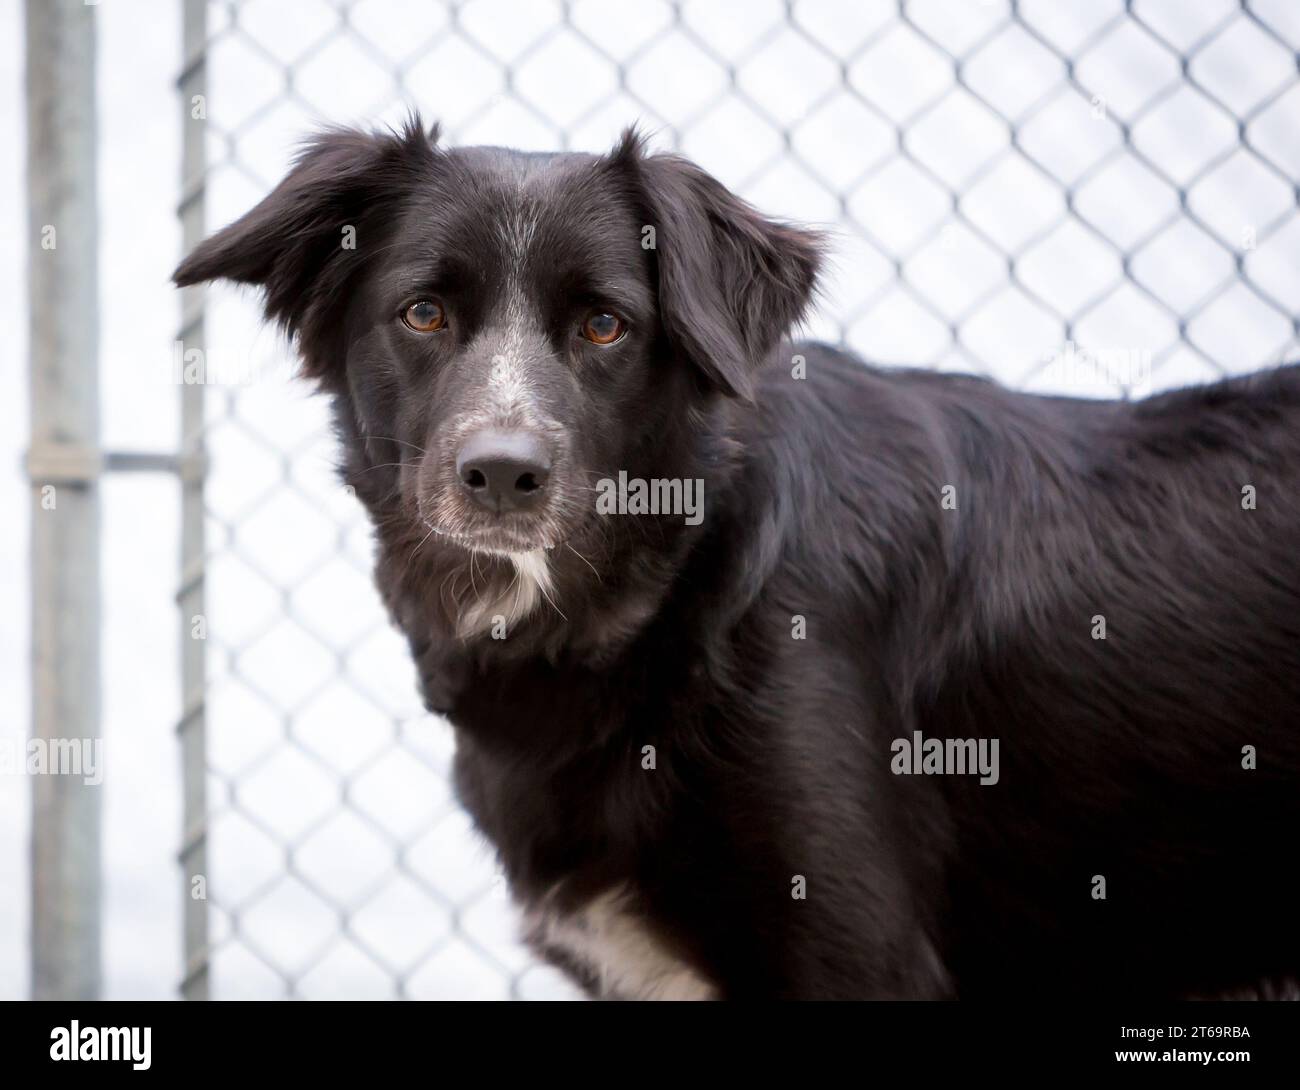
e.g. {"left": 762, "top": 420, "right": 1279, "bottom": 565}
{"left": 26, "top": 0, "right": 101, "bottom": 999}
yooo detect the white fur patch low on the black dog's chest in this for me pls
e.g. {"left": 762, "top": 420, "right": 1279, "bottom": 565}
{"left": 524, "top": 886, "right": 718, "bottom": 1000}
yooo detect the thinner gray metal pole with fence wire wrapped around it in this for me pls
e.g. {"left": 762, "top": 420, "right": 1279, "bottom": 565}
{"left": 177, "top": 0, "right": 209, "bottom": 999}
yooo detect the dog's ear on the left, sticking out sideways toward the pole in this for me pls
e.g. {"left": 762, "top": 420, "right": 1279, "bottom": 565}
{"left": 172, "top": 116, "right": 438, "bottom": 377}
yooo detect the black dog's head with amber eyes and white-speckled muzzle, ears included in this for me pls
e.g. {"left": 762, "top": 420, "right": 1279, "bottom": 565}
{"left": 176, "top": 120, "right": 819, "bottom": 632}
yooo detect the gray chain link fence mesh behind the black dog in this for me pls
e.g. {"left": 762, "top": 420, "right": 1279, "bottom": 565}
{"left": 181, "top": 0, "right": 1300, "bottom": 998}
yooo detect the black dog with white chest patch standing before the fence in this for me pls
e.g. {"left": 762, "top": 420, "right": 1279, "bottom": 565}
{"left": 176, "top": 121, "right": 1300, "bottom": 998}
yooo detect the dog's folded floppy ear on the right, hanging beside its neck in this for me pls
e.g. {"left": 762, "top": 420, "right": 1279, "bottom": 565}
{"left": 610, "top": 129, "right": 823, "bottom": 398}
